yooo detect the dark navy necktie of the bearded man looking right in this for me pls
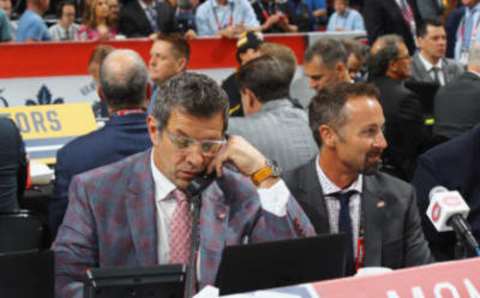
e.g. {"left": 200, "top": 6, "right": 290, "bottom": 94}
{"left": 332, "top": 190, "right": 357, "bottom": 276}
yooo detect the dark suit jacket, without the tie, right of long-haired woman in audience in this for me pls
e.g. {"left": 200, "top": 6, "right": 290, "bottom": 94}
{"left": 118, "top": 0, "right": 177, "bottom": 37}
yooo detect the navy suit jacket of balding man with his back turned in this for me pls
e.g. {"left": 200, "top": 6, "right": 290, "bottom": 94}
{"left": 48, "top": 113, "right": 151, "bottom": 237}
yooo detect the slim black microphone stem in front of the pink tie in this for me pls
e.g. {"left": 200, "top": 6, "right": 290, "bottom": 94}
{"left": 185, "top": 193, "right": 202, "bottom": 298}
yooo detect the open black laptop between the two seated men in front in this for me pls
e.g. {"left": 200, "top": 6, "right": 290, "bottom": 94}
{"left": 216, "top": 234, "right": 347, "bottom": 295}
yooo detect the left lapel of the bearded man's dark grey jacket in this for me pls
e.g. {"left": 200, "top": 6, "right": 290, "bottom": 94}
{"left": 297, "top": 158, "right": 330, "bottom": 234}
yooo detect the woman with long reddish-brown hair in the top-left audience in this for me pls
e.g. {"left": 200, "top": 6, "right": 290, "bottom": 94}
{"left": 77, "top": 0, "right": 117, "bottom": 40}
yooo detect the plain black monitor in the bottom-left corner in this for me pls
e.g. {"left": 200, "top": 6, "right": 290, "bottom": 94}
{"left": 0, "top": 250, "right": 54, "bottom": 298}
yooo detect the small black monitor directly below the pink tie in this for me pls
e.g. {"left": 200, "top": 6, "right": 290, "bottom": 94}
{"left": 84, "top": 265, "right": 186, "bottom": 298}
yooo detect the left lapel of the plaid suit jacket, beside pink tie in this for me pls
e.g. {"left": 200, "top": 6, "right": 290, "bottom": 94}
{"left": 125, "top": 150, "right": 158, "bottom": 266}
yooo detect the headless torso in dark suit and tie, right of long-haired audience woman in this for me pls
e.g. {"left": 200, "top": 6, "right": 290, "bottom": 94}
{"left": 118, "top": 0, "right": 177, "bottom": 38}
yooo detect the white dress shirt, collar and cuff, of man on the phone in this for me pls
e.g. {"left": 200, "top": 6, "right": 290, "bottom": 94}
{"left": 150, "top": 149, "right": 290, "bottom": 264}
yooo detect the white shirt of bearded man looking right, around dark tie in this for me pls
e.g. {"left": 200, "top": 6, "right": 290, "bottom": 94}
{"left": 315, "top": 155, "right": 363, "bottom": 257}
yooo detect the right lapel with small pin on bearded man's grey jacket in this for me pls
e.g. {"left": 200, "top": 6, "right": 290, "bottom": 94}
{"left": 362, "top": 176, "right": 386, "bottom": 266}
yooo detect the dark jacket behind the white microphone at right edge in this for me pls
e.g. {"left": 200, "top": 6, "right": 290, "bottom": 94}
{"left": 412, "top": 126, "right": 480, "bottom": 260}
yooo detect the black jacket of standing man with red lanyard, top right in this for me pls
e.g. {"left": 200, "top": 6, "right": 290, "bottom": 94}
{"left": 363, "top": 0, "right": 421, "bottom": 55}
